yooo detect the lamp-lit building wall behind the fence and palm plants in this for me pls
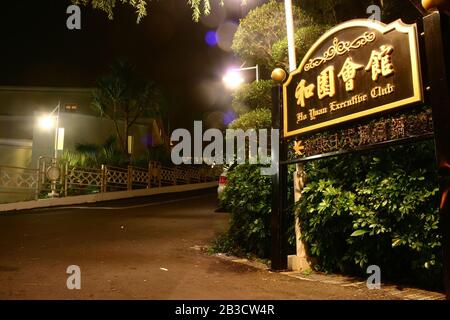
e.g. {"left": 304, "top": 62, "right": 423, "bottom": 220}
{"left": 0, "top": 86, "right": 164, "bottom": 168}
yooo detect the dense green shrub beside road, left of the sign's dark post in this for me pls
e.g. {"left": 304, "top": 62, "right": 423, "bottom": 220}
{"left": 212, "top": 164, "right": 295, "bottom": 258}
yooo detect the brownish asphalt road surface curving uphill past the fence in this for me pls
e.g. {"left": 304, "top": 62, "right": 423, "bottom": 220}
{"left": 0, "top": 189, "right": 392, "bottom": 299}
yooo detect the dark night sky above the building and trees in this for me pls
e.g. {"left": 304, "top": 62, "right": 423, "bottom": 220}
{"left": 0, "top": 0, "right": 262, "bottom": 128}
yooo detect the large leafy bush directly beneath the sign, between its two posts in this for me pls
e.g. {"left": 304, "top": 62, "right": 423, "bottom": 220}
{"left": 298, "top": 142, "right": 442, "bottom": 286}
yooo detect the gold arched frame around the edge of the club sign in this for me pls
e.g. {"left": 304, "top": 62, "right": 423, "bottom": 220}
{"left": 283, "top": 19, "right": 423, "bottom": 138}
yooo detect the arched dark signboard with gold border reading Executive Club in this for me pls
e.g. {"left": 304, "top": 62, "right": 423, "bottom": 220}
{"left": 283, "top": 20, "right": 423, "bottom": 138}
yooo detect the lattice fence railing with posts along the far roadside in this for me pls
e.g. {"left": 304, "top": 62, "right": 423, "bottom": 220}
{"left": 0, "top": 158, "right": 221, "bottom": 203}
